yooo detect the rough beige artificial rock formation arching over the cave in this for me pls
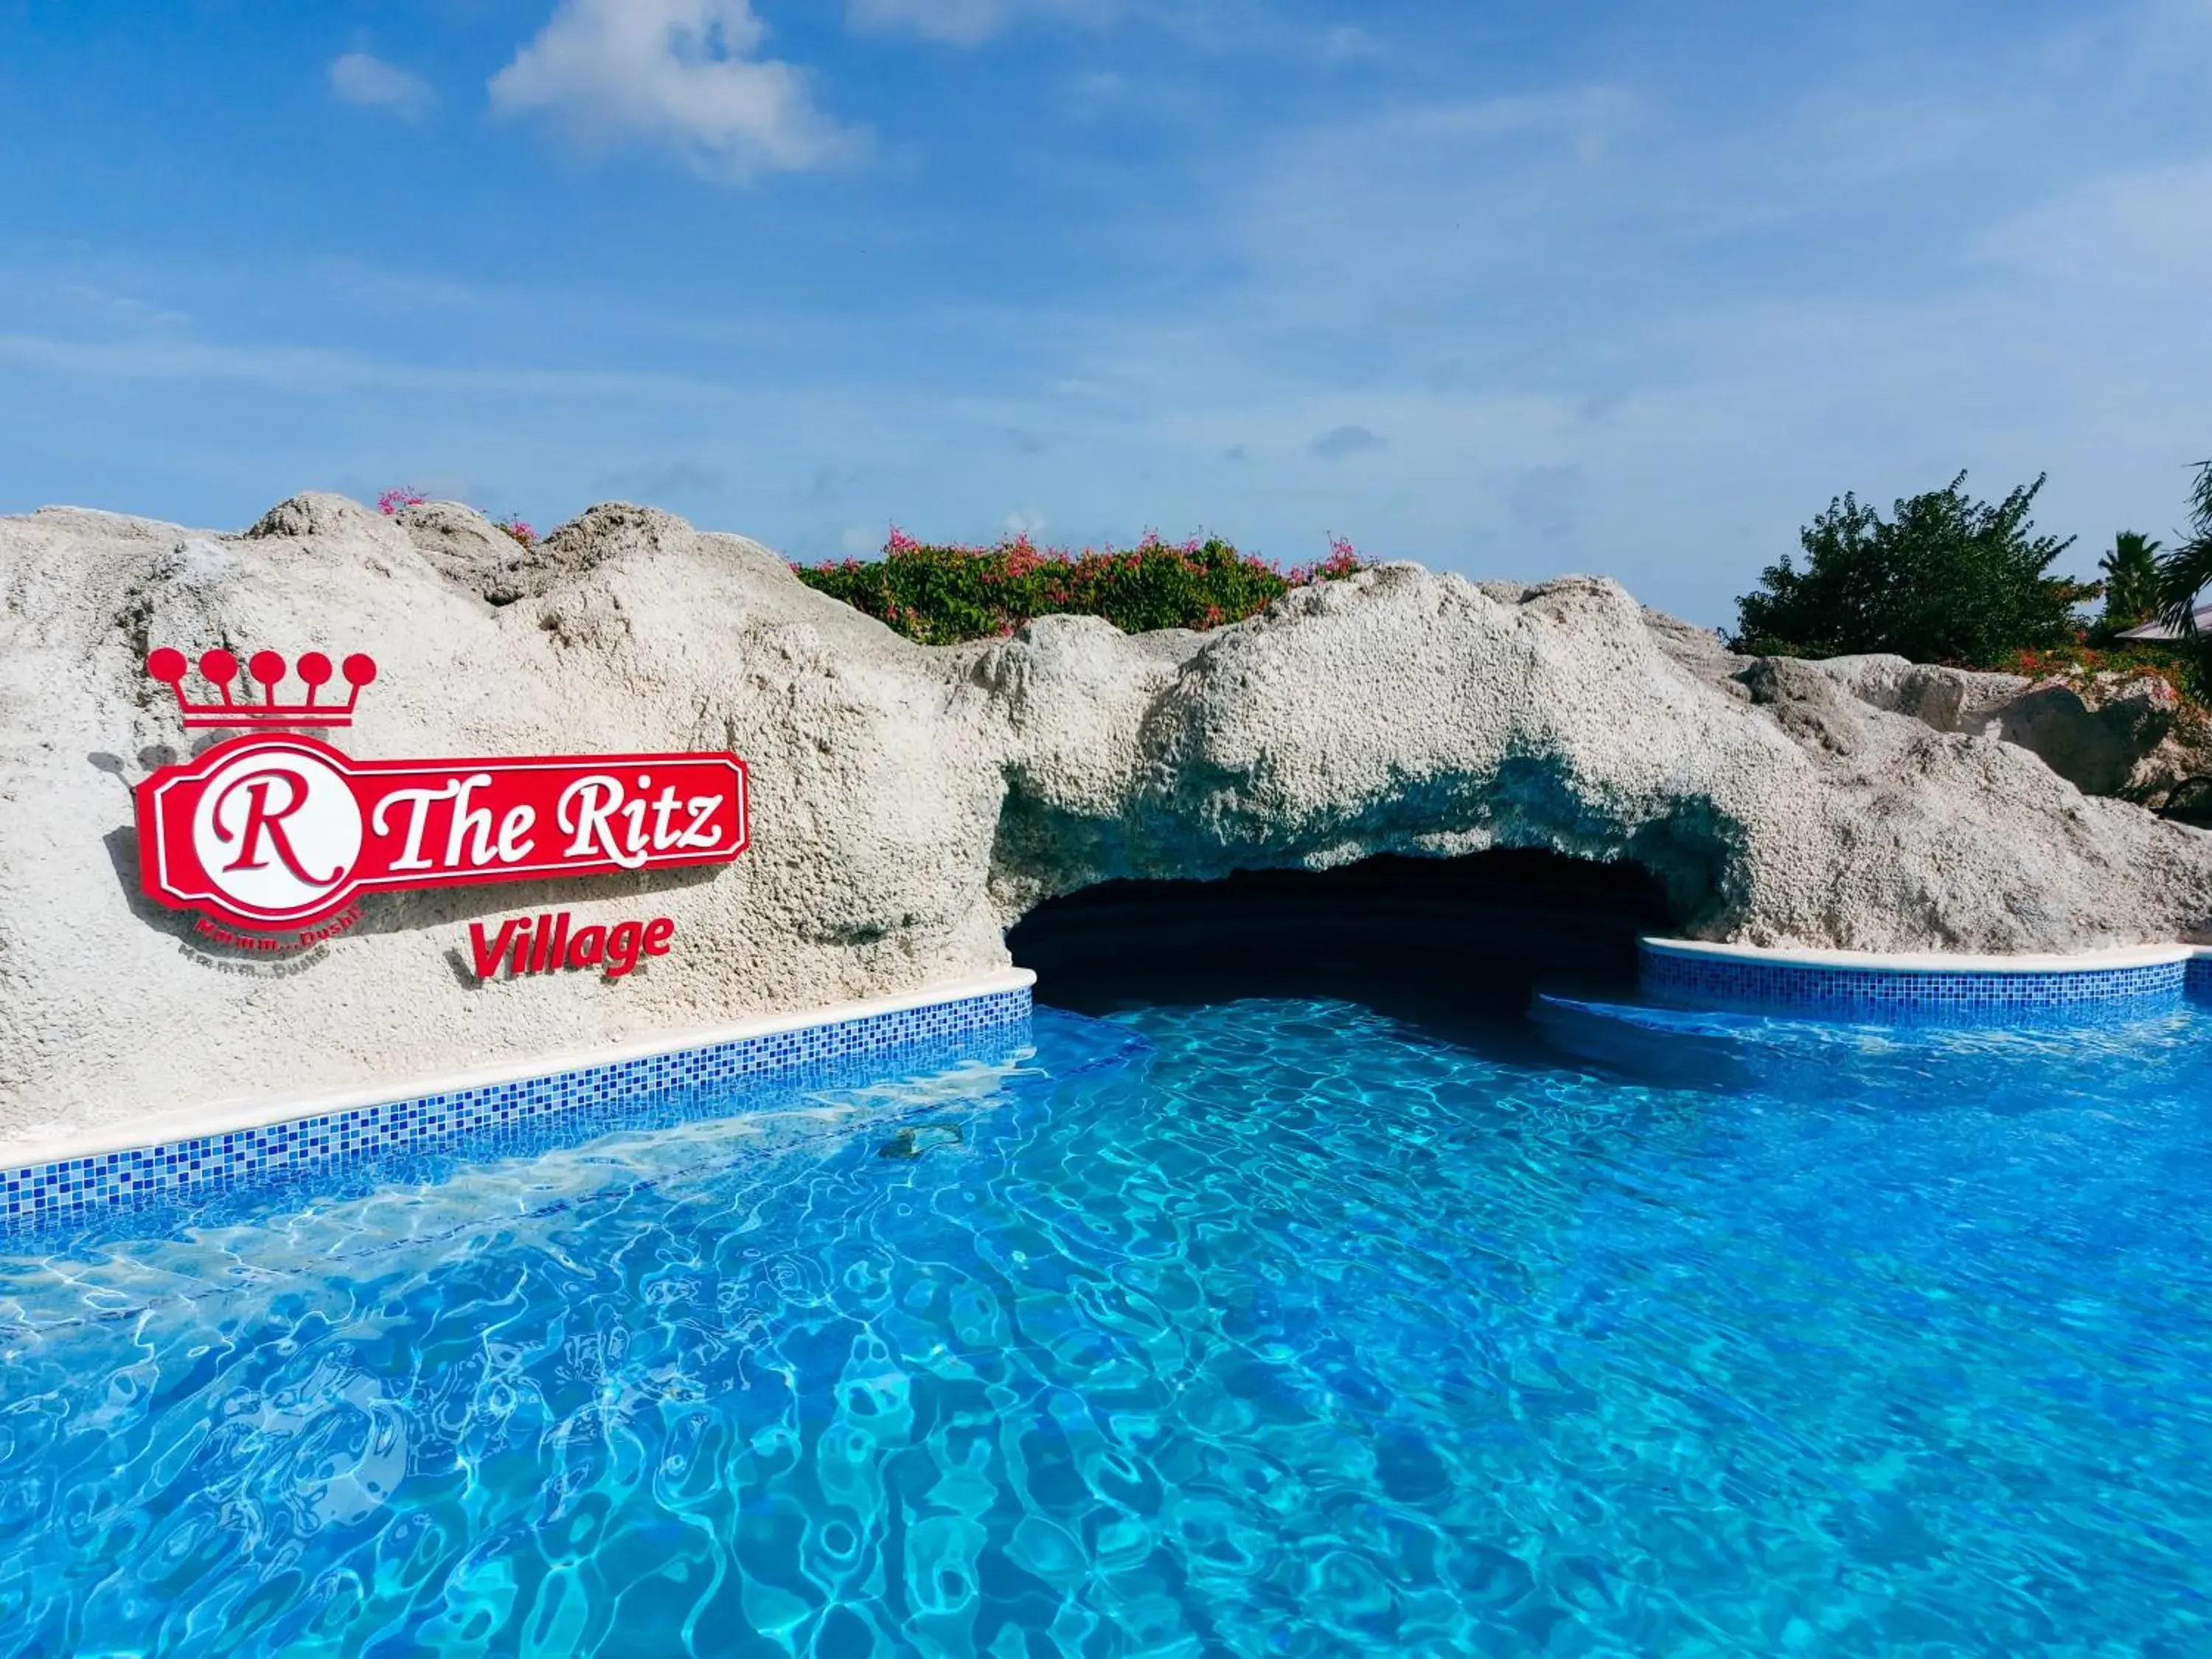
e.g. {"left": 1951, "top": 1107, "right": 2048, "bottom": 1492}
{"left": 0, "top": 495, "right": 2212, "bottom": 1141}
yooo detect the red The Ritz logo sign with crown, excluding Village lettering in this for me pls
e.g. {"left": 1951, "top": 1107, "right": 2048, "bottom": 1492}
{"left": 137, "top": 650, "right": 750, "bottom": 929}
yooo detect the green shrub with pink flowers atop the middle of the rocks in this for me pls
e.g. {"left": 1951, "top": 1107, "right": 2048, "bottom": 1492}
{"left": 792, "top": 529, "right": 1367, "bottom": 646}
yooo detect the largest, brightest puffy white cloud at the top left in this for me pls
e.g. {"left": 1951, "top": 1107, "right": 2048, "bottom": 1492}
{"left": 491, "top": 0, "right": 860, "bottom": 179}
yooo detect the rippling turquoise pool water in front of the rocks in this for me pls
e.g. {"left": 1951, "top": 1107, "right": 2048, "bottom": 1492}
{"left": 0, "top": 1002, "right": 2212, "bottom": 1659}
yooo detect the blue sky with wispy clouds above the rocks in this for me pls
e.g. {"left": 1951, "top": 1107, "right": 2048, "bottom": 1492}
{"left": 0, "top": 0, "right": 2212, "bottom": 624}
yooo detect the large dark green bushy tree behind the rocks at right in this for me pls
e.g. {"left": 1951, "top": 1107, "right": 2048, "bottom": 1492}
{"left": 1730, "top": 473, "right": 2097, "bottom": 668}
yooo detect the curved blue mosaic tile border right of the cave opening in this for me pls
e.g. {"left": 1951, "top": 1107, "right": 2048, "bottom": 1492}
{"left": 1639, "top": 947, "right": 2185, "bottom": 1026}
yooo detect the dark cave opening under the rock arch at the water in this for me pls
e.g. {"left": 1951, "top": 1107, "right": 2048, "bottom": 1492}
{"left": 1006, "top": 847, "right": 1670, "bottom": 1029}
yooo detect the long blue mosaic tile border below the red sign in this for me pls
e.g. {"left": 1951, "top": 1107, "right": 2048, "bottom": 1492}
{"left": 0, "top": 987, "right": 1031, "bottom": 1234}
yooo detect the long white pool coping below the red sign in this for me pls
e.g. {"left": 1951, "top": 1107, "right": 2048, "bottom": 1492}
{"left": 0, "top": 969, "right": 1037, "bottom": 1170}
